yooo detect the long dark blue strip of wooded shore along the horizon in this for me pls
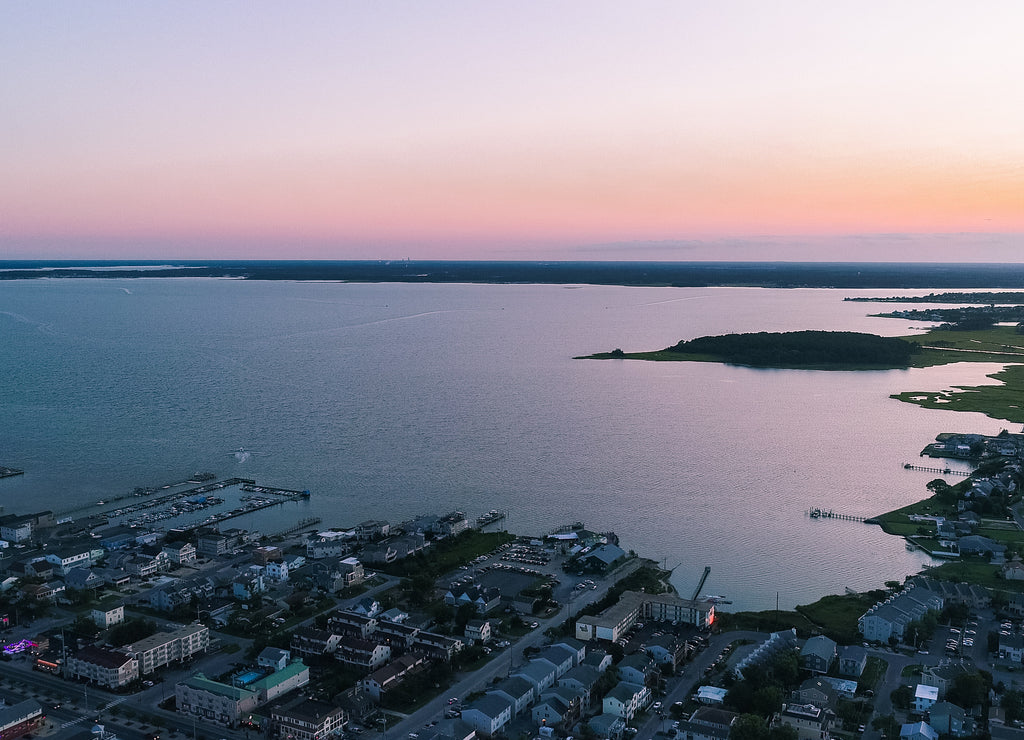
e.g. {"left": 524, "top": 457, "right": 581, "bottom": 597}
{"left": 9, "top": 260, "right": 1024, "bottom": 288}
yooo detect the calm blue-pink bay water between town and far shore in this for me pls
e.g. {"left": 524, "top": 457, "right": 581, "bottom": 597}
{"left": 0, "top": 278, "right": 1007, "bottom": 609}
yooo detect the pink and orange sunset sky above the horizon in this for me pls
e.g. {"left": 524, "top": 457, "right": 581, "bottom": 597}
{"left": 0, "top": 0, "right": 1024, "bottom": 262}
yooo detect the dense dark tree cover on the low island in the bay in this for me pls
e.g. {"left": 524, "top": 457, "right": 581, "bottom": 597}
{"left": 664, "top": 332, "right": 921, "bottom": 367}
